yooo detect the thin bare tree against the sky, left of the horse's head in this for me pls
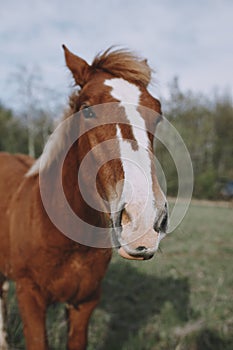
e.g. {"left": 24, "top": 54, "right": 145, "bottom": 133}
{"left": 11, "top": 66, "right": 58, "bottom": 158}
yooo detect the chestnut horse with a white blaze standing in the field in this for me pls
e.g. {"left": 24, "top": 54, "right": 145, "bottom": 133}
{"left": 0, "top": 45, "right": 168, "bottom": 350}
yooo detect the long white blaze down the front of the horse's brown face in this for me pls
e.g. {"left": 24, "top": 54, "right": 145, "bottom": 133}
{"left": 104, "top": 78, "right": 156, "bottom": 230}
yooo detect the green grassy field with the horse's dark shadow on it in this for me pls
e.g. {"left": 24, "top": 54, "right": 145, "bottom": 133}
{"left": 4, "top": 202, "right": 233, "bottom": 350}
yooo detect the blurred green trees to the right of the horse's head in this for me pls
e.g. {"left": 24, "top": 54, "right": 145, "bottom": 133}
{"left": 156, "top": 79, "right": 233, "bottom": 199}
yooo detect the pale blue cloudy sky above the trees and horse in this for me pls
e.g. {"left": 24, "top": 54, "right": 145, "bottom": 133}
{"left": 0, "top": 0, "right": 233, "bottom": 108}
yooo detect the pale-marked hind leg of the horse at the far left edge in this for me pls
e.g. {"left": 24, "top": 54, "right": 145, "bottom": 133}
{"left": 0, "top": 274, "right": 9, "bottom": 350}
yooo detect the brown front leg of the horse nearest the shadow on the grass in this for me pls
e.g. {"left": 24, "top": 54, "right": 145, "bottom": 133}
{"left": 67, "top": 293, "right": 100, "bottom": 350}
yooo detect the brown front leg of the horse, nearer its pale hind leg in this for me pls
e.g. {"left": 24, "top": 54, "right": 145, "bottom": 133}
{"left": 16, "top": 278, "right": 48, "bottom": 350}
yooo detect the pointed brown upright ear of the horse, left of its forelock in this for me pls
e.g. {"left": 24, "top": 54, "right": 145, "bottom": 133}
{"left": 62, "top": 45, "right": 90, "bottom": 87}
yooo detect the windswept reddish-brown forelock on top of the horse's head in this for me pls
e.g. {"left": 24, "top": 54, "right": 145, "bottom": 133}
{"left": 91, "top": 47, "right": 152, "bottom": 87}
